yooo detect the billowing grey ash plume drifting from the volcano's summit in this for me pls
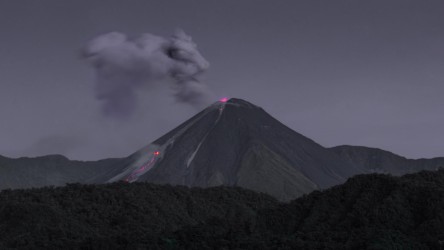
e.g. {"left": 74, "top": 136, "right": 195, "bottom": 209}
{"left": 83, "top": 30, "right": 212, "bottom": 118}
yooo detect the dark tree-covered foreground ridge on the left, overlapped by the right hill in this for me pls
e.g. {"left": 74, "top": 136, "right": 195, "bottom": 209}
{"left": 0, "top": 182, "right": 277, "bottom": 249}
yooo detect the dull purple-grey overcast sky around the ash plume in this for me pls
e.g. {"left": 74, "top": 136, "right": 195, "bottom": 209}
{"left": 0, "top": 0, "right": 444, "bottom": 159}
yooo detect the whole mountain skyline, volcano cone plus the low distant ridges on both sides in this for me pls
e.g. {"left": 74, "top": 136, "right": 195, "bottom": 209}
{"left": 0, "top": 98, "right": 444, "bottom": 201}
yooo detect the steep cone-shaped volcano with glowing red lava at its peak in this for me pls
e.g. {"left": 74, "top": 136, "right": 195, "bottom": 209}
{"left": 93, "top": 98, "right": 366, "bottom": 200}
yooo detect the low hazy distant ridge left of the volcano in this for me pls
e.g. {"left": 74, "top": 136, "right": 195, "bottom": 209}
{"left": 0, "top": 155, "right": 120, "bottom": 190}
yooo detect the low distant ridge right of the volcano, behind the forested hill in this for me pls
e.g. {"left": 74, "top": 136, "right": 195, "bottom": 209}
{"left": 329, "top": 145, "right": 444, "bottom": 175}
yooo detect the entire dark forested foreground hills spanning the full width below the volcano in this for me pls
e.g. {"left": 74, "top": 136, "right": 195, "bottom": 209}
{"left": 0, "top": 170, "right": 444, "bottom": 249}
